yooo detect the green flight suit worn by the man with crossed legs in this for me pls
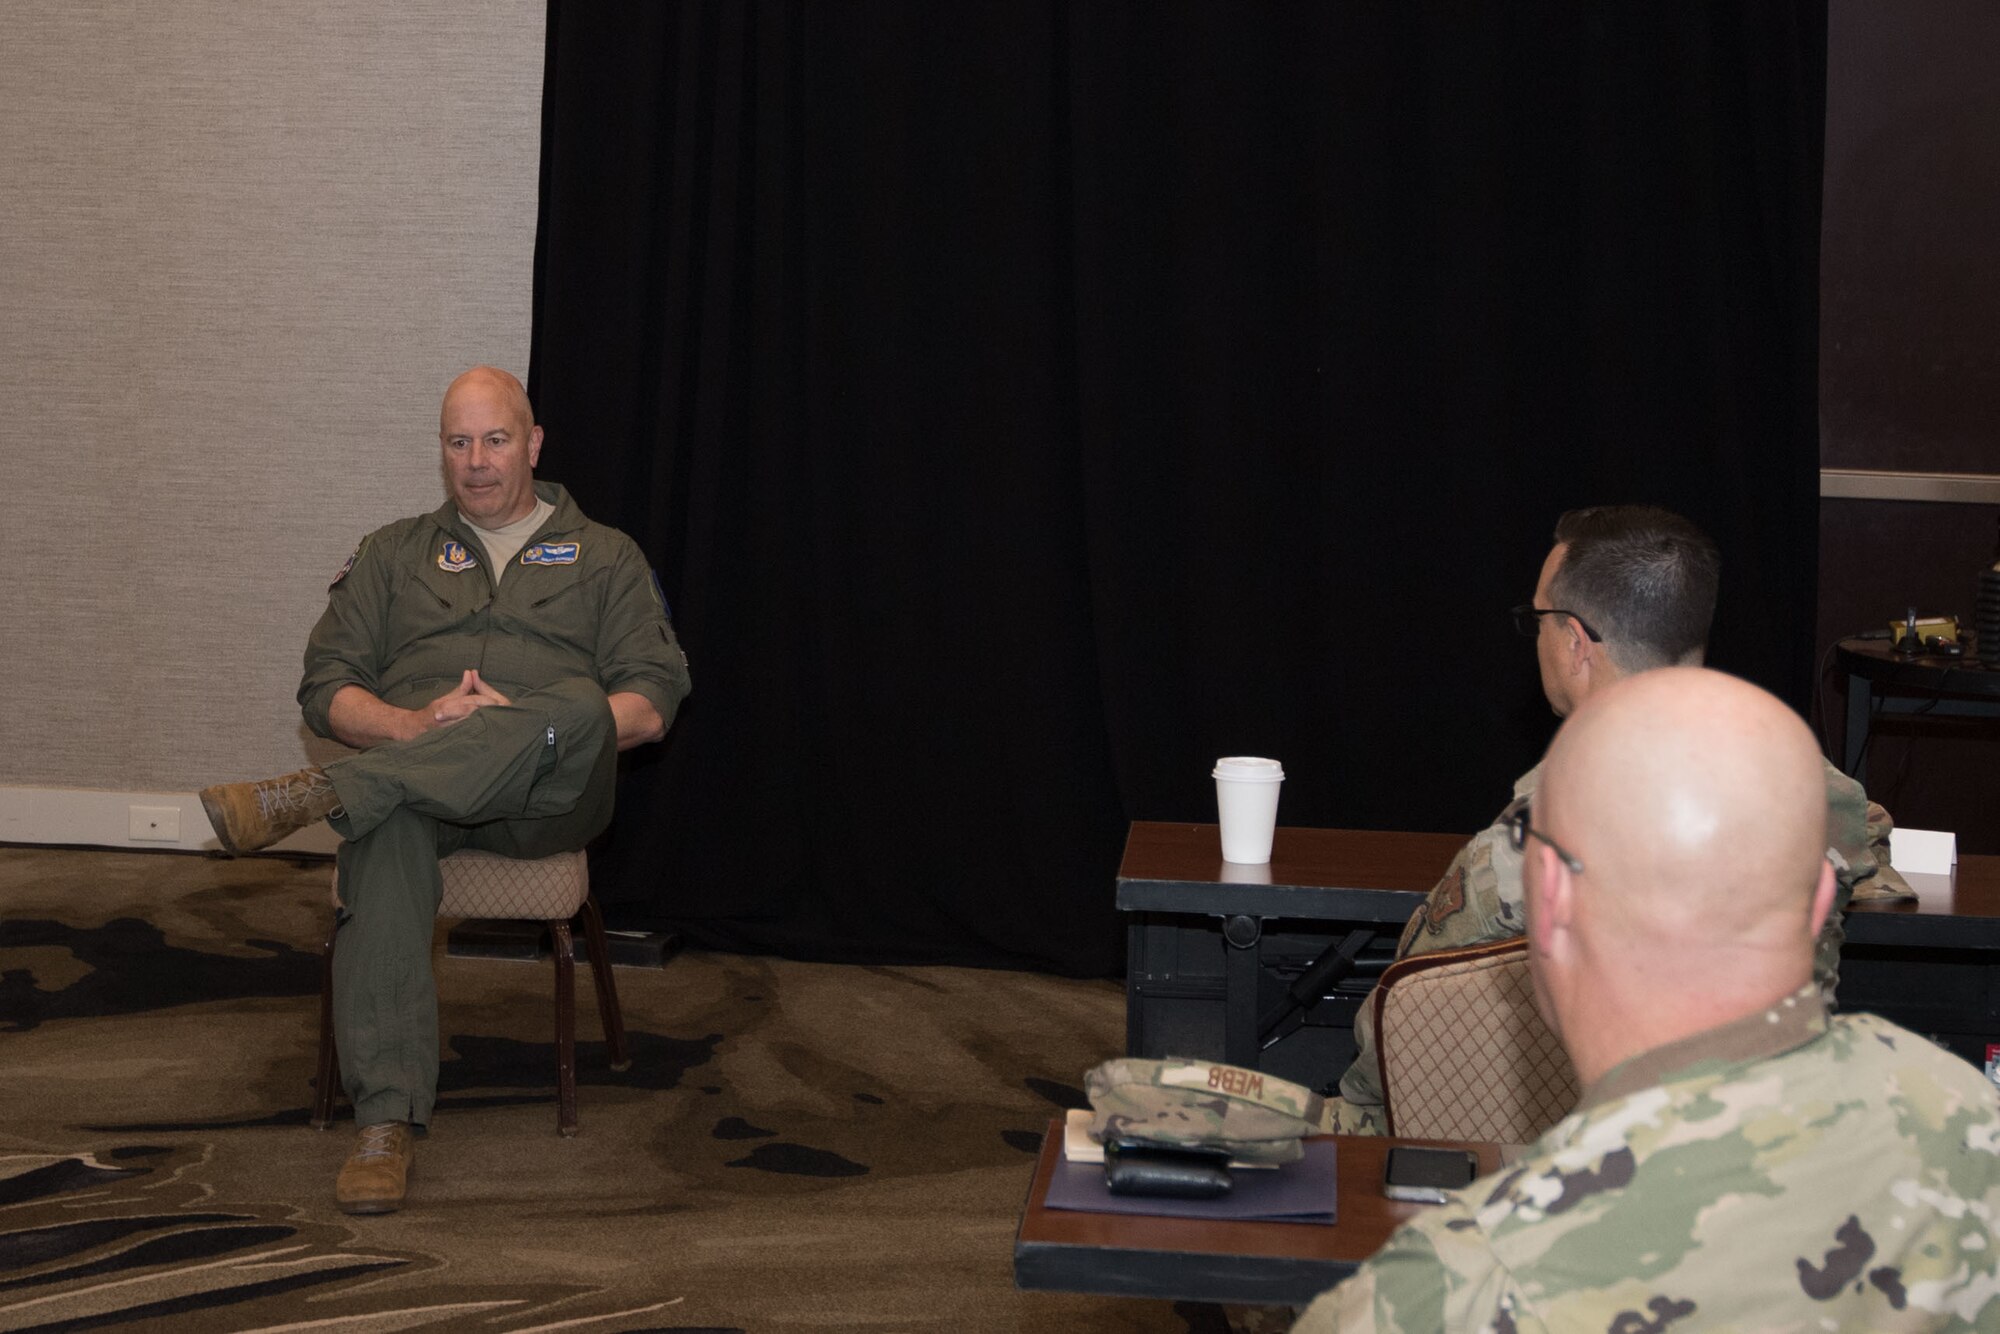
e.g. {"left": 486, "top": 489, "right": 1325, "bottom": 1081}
{"left": 298, "top": 482, "right": 688, "bottom": 1126}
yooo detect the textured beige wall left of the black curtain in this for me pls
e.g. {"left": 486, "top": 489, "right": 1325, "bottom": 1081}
{"left": 0, "top": 0, "right": 544, "bottom": 790}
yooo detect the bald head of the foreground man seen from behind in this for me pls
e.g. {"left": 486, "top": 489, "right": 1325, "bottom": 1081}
{"left": 1524, "top": 668, "right": 1832, "bottom": 1080}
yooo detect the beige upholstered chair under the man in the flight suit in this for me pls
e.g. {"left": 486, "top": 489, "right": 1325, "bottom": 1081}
{"left": 312, "top": 850, "right": 632, "bottom": 1136}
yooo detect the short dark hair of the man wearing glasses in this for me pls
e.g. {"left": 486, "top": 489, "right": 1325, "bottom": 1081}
{"left": 1548, "top": 504, "right": 1722, "bottom": 672}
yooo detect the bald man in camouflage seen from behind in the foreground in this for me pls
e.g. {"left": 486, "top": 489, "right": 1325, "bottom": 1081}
{"left": 1296, "top": 668, "right": 2000, "bottom": 1334}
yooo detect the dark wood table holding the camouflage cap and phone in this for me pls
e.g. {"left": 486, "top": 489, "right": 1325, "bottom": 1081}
{"left": 1014, "top": 1120, "right": 1502, "bottom": 1306}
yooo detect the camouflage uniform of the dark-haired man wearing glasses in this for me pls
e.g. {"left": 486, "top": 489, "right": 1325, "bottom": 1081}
{"left": 1324, "top": 764, "right": 1910, "bottom": 1134}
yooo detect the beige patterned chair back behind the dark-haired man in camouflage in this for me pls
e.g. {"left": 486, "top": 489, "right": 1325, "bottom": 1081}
{"left": 1374, "top": 938, "right": 1582, "bottom": 1144}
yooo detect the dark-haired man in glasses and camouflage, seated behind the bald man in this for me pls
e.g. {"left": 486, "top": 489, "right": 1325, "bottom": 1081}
{"left": 1326, "top": 504, "right": 1912, "bottom": 1134}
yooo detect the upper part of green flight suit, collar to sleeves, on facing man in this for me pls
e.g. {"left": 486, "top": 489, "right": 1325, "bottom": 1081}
{"left": 298, "top": 482, "right": 688, "bottom": 736}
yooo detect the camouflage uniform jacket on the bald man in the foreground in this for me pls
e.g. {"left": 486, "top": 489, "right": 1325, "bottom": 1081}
{"left": 1294, "top": 984, "right": 2000, "bottom": 1334}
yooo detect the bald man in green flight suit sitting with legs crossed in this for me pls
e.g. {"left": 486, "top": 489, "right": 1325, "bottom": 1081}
{"left": 202, "top": 366, "right": 688, "bottom": 1214}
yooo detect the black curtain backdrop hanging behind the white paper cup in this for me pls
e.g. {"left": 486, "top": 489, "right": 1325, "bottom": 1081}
{"left": 530, "top": 0, "right": 1824, "bottom": 974}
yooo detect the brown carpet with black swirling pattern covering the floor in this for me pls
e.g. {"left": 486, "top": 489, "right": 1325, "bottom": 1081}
{"left": 0, "top": 848, "right": 1222, "bottom": 1334}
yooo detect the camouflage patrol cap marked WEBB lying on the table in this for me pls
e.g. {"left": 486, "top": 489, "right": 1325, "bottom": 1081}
{"left": 1084, "top": 1056, "right": 1324, "bottom": 1162}
